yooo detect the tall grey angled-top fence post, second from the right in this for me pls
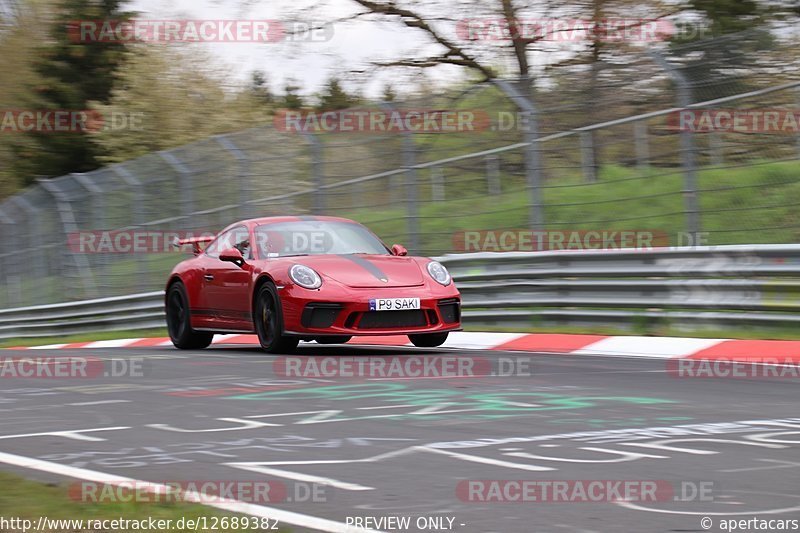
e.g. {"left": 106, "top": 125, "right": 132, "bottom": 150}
{"left": 492, "top": 78, "right": 545, "bottom": 231}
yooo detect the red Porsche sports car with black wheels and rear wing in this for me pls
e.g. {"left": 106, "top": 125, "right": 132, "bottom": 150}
{"left": 165, "top": 216, "right": 461, "bottom": 352}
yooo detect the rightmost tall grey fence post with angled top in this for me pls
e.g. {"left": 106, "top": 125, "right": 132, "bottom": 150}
{"left": 650, "top": 50, "right": 700, "bottom": 242}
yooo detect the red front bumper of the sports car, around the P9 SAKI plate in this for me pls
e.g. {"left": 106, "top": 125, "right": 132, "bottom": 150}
{"left": 281, "top": 285, "right": 461, "bottom": 335}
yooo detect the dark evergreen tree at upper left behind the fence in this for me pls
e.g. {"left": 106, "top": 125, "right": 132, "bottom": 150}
{"left": 12, "top": 0, "right": 131, "bottom": 183}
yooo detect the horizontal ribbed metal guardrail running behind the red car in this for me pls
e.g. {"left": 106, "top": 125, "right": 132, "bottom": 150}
{"left": 0, "top": 245, "right": 800, "bottom": 339}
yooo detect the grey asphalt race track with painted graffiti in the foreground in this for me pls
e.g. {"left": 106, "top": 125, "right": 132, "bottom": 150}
{"left": 0, "top": 344, "right": 800, "bottom": 532}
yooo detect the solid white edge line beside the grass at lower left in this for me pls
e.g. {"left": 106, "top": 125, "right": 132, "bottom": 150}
{"left": 0, "top": 452, "right": 379, "bottom": 533}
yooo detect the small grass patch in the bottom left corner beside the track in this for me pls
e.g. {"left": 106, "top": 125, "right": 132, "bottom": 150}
{"left": 0, "top": 472, "right": 286, "bottom": 531}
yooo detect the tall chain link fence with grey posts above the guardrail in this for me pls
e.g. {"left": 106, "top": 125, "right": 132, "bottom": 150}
{"left": 0, "top": 32, "right": 800, "bottom": 308}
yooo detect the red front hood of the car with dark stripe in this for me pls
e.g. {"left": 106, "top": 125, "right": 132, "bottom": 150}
{"left": 298, "top": 254, "right": 425, "bottom": 288}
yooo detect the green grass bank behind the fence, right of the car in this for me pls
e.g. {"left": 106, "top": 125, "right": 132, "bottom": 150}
{"left": 354, "top": 161, "right": 800, "bottom": 251}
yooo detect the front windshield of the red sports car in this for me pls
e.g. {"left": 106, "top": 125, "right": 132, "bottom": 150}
{"left": 255, "top": 220, "right": 390, "bottom": 259}
